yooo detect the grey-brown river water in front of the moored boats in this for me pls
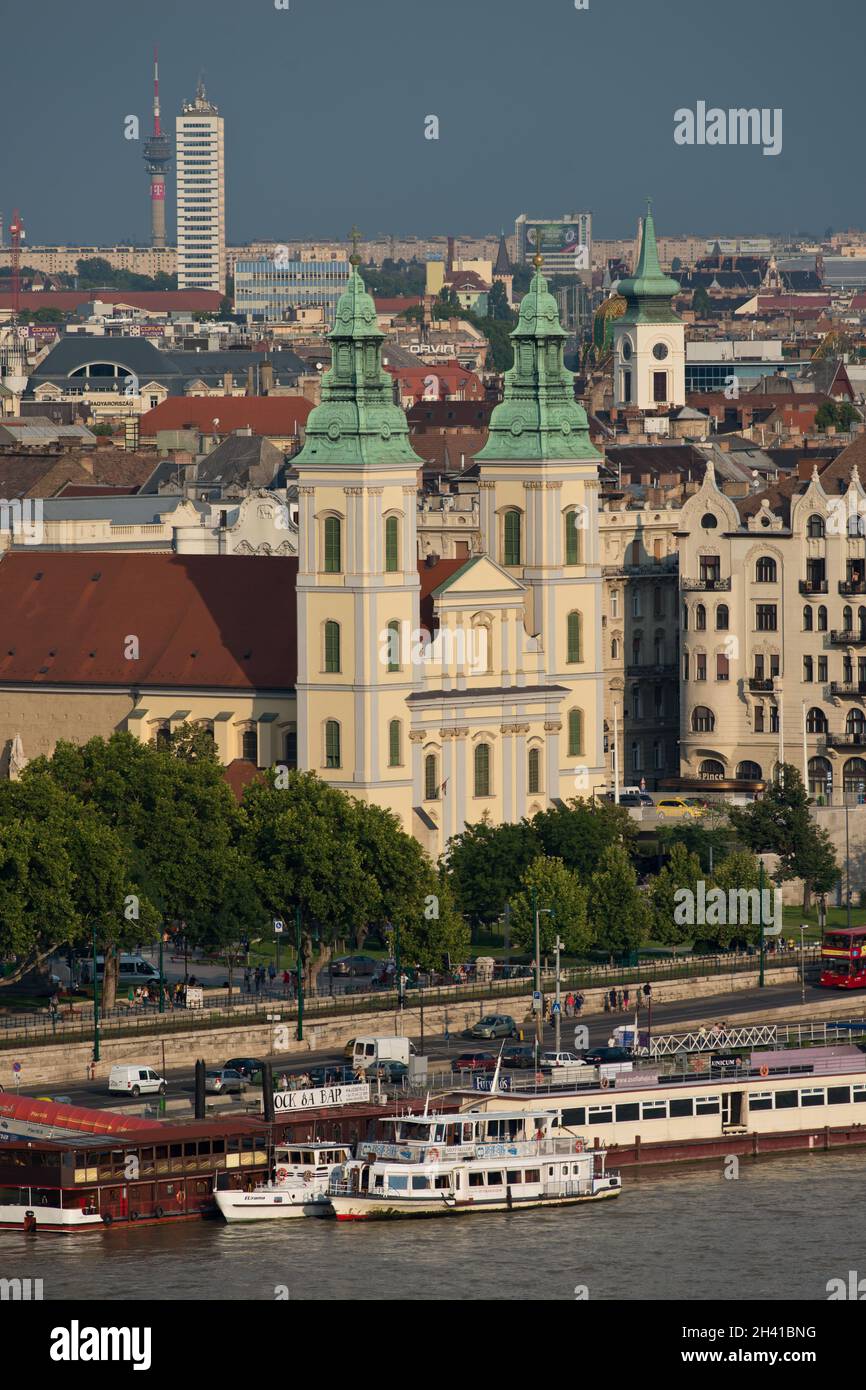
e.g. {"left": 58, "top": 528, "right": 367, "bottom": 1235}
{"left": 0, "top": 1151, "right": 866, "bottom": 1300}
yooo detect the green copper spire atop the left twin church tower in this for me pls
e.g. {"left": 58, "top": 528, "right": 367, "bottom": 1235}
{"left": 292, "top": 257, "right": 423, "bottom": 468}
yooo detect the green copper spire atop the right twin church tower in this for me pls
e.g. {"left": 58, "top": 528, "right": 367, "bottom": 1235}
{"left": 475, "top": 265, "right": 601, "bottom": 461}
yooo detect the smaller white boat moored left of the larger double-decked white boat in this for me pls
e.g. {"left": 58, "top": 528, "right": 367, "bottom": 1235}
{"left": 214, "top": 1143, "right": 352, "bottom": 1220}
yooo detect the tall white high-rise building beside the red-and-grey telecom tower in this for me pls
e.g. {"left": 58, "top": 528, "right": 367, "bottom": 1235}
{"left": 177, "top": 81, "right": 225, "bottom": 292}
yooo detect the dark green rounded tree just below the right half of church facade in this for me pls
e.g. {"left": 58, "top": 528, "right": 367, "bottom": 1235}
{"left": 443, "top": 815, "right": 539, "bottom": 926}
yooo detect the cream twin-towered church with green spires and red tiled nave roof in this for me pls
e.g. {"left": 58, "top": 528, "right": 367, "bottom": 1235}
{"left": 0, "top": 239, "right": 606, "bottom": 856}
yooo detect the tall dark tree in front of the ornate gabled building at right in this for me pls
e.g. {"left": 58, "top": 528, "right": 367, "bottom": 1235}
{"left": 728, "top": 763, "right": 840, "bottom": 912}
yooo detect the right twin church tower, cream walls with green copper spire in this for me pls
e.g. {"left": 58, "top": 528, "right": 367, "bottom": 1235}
{"left": 475, "top": 244, "right": 603, "bottom": 799}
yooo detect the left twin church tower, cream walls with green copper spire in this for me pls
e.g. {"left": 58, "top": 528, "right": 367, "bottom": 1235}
{"left": 293, "top": 238, "right": 421, "bottom": 830}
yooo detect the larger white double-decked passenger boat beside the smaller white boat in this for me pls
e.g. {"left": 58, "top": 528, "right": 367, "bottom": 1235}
{"left": 328, "top": 1109, "right": 620, "bottom": 1220}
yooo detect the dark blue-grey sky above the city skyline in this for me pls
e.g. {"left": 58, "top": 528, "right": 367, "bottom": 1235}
{"left": 0, "top": 0, "right": 866, "bottom": 245}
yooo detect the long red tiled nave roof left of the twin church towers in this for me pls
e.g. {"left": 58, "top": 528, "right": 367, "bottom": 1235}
{"left": 0, "top": 553, "right": 297, "bottom": 692}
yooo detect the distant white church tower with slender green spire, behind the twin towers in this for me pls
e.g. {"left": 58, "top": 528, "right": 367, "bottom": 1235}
{"left": 613, "top": 204, "right": 685, "bottom": 410}
